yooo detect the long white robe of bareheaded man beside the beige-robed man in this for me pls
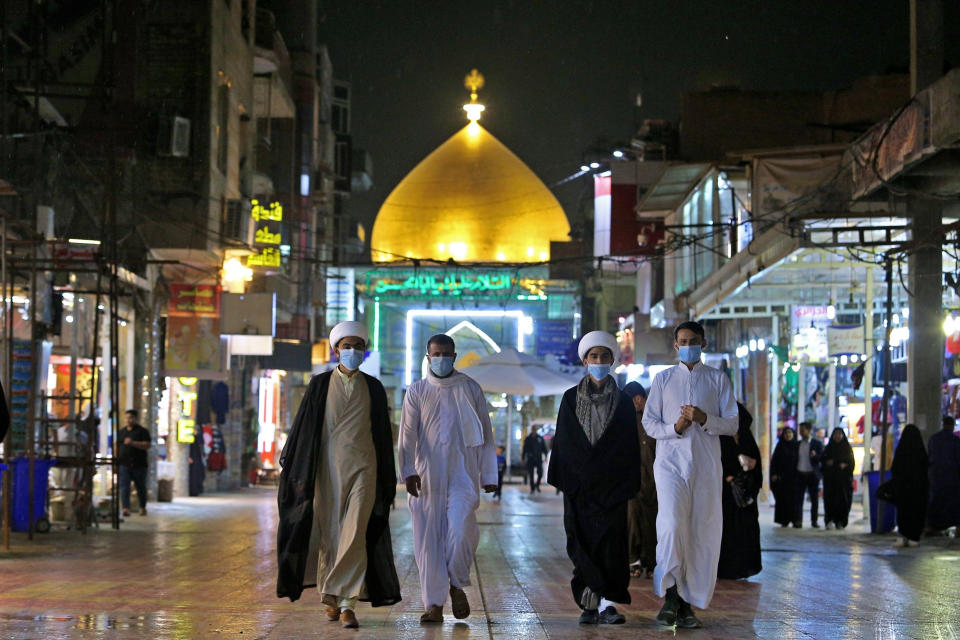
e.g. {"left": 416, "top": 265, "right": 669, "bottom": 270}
{"left": 397, "top": 371, "right": 497, "bottom": 608}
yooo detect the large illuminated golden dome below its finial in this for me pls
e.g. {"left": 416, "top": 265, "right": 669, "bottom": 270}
{"left": 370, "top": 122, "right": 570, "bottom": 262}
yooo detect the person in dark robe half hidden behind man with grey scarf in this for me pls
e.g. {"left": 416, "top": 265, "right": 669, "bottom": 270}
{"left": 623, "top": 381, "right": 657, "bottom": 578}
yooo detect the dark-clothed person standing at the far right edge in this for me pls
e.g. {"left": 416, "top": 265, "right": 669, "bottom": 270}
{"left": 927, "top": 416, "right": 960, "bottom": 534}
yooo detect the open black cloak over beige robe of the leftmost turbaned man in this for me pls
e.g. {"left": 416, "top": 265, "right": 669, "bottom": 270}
{"left": 277, "top": 371, "right": 400, "bottom": 607}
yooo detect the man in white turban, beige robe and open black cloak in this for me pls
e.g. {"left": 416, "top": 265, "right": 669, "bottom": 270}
{"left": 277, "top": 322, "right": 400, "bottom": 628}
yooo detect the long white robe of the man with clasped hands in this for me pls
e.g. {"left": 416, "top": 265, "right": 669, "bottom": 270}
{"left": 643, "top": 363, "right": 739, "bottom": 609}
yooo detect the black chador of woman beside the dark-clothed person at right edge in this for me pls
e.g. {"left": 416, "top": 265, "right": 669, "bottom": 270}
{"left": 890, "top": 424, "right": 930, "bottom": 540}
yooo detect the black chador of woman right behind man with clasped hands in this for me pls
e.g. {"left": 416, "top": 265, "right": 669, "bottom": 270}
{"left": 717, "top": 402, "right": 763, "bottom": 580}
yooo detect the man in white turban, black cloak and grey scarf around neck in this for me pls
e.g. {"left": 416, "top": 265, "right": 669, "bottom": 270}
{"left": 547, "top": 331, "right": 640, "bottom": 624}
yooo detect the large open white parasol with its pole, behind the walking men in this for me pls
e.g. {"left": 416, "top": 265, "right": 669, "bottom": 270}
{"left": 464, "top": 348, "right": 580, "bottom": 472}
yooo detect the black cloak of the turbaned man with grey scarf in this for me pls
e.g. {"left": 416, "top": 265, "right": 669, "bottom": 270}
{"left": 547, "top": 380, "right": 641, "bottom": 605}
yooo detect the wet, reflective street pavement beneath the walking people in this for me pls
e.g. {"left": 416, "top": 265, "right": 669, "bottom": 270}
{"left": 0, "top": 488, "right": 960, "bottom": 640}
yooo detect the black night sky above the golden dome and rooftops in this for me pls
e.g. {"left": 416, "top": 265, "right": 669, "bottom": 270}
{"left": 321, "top": 0, "right": 960, "bottom": 236}
